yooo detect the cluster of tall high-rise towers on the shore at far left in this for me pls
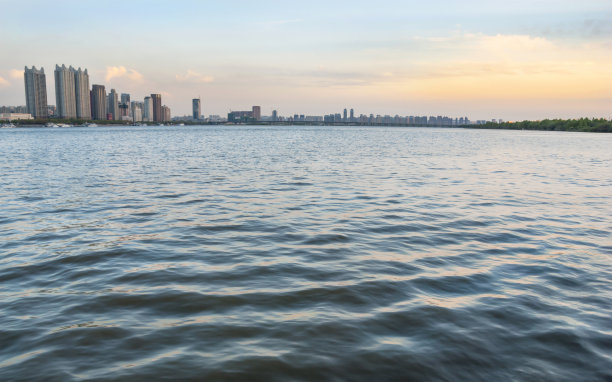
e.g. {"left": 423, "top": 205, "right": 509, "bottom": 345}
{"left": 19, "top": 65, "right": 172, "bottom": 122}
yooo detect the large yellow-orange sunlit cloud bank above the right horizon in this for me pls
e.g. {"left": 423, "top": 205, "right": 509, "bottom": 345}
{"left": 346, "top": 33, "right": 612, "bottom": 100}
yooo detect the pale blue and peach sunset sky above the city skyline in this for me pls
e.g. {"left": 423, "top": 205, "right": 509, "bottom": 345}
{"left": 0, "top": 0, "right": 612, "bottom": 120}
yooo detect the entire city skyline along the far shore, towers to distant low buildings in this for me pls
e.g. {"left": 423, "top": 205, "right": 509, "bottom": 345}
{"left": 0, "top": 65, "right": 503, "bottom": 127}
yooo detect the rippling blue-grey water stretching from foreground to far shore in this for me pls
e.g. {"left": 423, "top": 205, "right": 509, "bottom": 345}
{"left": 0, "top": 127, "right": 612, "bottom": 381}
